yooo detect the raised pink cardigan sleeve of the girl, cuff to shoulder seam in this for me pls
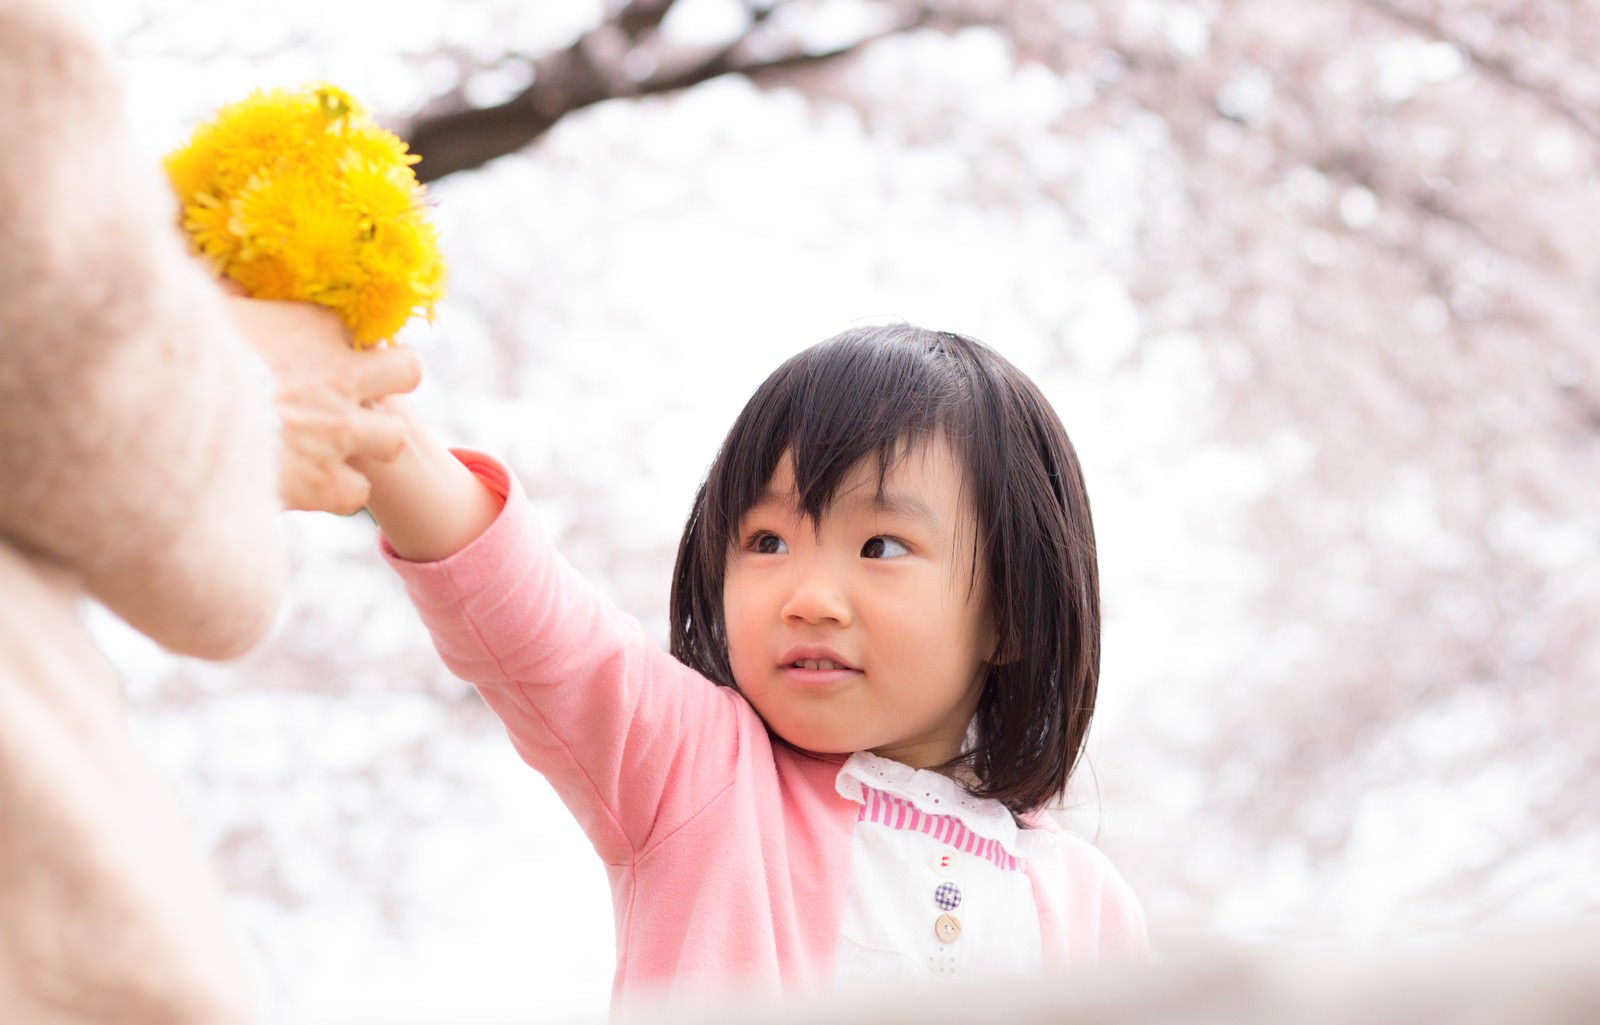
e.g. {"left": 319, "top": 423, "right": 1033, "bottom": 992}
{"left": 382, "top": 451, "right": 758, "bottom": 865}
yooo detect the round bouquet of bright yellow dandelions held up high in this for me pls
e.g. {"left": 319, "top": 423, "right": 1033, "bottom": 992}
{"left": 165, "top": 85, "right": 445, "bottom": 349}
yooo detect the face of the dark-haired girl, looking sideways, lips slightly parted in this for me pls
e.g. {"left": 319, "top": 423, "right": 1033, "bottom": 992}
{"left": 723, "top": 440, "right": 995, "bottom": 768}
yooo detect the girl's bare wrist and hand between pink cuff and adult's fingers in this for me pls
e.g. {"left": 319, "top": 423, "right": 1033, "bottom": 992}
{"left": 352, "top": 398, "right": 504, "bottom": 563}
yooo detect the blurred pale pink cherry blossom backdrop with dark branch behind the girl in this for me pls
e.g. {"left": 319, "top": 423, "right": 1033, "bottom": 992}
{"left": 90, "top": 0, "right": 1600, "bottom": 1023}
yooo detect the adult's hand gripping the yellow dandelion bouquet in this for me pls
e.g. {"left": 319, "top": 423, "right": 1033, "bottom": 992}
{"left": 226, "top": 296, "right": 422, "bottom": 513}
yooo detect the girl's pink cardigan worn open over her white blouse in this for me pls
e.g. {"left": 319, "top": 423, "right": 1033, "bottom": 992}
{"left": 384, "top": 453, "right": 1144, "bottom": 996}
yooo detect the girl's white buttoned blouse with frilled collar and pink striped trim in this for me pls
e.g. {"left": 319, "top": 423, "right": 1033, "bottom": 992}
{"left": 834, "top": 752, "right": 1056, "bottom": 990}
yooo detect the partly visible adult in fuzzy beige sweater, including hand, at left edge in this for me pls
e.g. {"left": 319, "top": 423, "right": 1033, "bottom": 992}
{"left": 0, "top": 0, "right": 414, "bottom": 1025}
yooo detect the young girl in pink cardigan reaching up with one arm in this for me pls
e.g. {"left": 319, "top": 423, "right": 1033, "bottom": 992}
{"left": 363, "top": 326, "right": 1146, "bottom": 996}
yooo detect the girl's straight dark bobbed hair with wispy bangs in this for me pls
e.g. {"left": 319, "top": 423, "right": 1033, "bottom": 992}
{"left": 670, "top": 325, "right": 1101, "bottom": 814}
